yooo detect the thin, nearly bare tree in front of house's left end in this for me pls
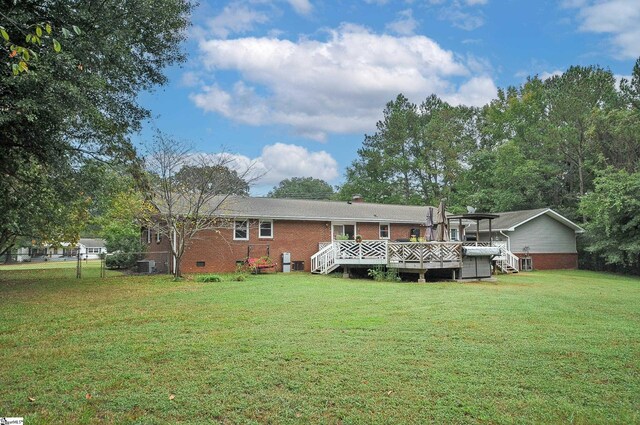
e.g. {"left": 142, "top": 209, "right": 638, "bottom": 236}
{"left": 146, "top": 133, "right": 259, "bottom": 278}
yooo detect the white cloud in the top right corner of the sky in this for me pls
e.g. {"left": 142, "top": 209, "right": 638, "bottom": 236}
{"left": 564, "top": 0, "right": 640, "bottom": 59}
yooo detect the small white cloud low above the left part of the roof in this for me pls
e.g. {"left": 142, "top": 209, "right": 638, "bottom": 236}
{"left": 212, "top": 143, "right": 339, "bottom": 186}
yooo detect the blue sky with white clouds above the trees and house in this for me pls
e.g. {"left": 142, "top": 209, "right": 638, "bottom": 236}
{"left": 134, "top": 0, "right": 640, "bottom": 195}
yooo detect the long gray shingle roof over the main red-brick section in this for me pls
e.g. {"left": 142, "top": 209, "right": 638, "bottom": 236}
{"left": 210, "top": 196, "right": 436, "bottom": 223}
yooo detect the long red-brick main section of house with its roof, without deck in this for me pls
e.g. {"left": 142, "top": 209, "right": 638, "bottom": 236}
{"left": 142, "top": 196, "right": 436, "bottom": 273}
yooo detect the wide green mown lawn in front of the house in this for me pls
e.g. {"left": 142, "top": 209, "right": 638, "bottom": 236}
{"left": 0, "top": 268, "right": 640, "bottom": 425}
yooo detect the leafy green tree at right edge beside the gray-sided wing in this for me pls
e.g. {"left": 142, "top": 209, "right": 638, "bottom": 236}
{"left": 580, "top": 167, "right": 640, "bottom": 274}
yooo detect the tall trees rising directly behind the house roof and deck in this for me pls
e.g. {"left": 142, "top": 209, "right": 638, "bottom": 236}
{"left": 340, "top": 94, "right": 478, "bottom": 205}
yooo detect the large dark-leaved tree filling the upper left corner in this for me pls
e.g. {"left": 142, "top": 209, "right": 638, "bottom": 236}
{"left": 0, "top": 0, "right": 192, "bottom": 249}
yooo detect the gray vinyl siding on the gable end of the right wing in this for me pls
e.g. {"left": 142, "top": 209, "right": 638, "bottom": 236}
{"left": 505, "top": 215, "right": 577, "bottom": 254}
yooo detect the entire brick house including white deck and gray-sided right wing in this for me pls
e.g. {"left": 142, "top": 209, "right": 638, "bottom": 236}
{"left": 142, "top": 196, "right": 582, "bottom": 279}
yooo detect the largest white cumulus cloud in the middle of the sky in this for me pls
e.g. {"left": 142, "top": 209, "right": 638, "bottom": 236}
{"left": 191, "top": 25, "right": 495, "bottom": 140}
